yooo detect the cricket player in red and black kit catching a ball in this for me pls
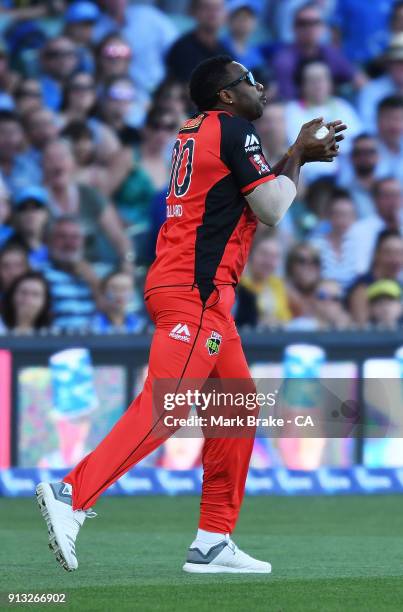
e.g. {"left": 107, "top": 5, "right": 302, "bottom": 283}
{"left": 36, "top": 56, "right": 346, "bottom": 574}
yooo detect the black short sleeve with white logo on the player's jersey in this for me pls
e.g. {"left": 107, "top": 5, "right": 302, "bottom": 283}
{"left": 220, "top": 113, "right": 276, "bottom": 194}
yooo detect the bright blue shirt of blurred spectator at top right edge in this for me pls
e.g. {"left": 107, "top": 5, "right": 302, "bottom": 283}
{"left": 331, "top": 0, "right": 396, "bottom": 64}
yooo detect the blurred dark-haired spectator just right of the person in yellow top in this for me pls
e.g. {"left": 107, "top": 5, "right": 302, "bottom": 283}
{"left": 286, "top": 242, "right": 321, "bottom": 327}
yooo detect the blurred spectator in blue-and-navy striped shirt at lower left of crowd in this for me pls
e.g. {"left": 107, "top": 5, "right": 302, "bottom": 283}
{"left": 43, "top": 216, "right": 99, "bottom": 330}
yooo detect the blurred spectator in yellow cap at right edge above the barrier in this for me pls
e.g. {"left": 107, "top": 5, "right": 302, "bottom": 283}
{"left": 367, "top": 279, "right": 403, "bottom": 329}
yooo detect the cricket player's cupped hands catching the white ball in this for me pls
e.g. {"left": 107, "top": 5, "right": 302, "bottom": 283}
{"left": 293, "top": 117, "right": 347, "bottom": 163}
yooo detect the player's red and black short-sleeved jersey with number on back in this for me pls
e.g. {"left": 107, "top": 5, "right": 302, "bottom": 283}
{"left": 145, "top": 111, "right": 275, "bottom": 302}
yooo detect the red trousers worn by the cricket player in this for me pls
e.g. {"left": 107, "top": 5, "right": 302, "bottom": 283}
{"left": 63, "top": 286, "right": 253, "bottom": 533}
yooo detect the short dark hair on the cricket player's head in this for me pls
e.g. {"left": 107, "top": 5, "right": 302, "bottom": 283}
{"left": 189, "top": 55, "right": 234, "bottom": 111}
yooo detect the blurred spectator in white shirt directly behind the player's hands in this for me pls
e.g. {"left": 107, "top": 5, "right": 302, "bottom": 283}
{"left": 286, "top": 60, "right": 362, "bottom": 183}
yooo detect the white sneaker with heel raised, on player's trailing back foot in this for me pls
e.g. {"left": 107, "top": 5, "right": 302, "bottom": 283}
{"left": 36, "top": 482, "right": 96, "bottom": 572}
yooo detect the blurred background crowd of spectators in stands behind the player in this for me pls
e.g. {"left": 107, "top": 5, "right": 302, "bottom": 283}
{"left": 0, "top": 0, "right": 403, "bottom": 333}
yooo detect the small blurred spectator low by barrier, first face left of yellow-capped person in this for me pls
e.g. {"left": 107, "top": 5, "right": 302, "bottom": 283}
{"left": 315, "top": 280, "right": 351, "bottom": 329}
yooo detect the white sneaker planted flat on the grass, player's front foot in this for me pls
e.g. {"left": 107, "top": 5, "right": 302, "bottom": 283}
{"left": 183, "top": 535, "right": 271, "bottom": 574}
